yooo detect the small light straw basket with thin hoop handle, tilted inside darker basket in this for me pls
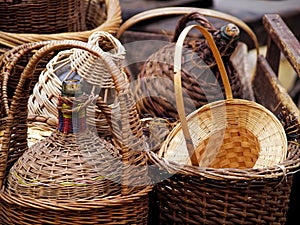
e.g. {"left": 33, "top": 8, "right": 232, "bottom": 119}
{"left": 160, "top": 25, "right": 287, "bottom": 169}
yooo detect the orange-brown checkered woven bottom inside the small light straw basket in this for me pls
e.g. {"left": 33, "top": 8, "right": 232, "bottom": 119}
{"left": 195, "top": 126, "right": 260, "bottom": 169}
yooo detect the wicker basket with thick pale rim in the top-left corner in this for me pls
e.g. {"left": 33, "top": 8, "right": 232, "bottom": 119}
{"left": 0, "top": 0, "right": 122, "bottom": 52}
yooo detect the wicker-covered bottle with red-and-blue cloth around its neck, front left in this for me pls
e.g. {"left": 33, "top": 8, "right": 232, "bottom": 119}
{"left": 6, "top": 79, "right": 122, "bottom": 200}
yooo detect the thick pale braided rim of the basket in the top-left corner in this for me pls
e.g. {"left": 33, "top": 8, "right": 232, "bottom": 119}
{"left": 0, "top": 0, "right": 122, "bottom": 51}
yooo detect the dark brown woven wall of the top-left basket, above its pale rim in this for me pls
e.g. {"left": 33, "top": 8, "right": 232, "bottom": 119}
{"left": 0, "top": 0, "right": 86, "bottom": 34}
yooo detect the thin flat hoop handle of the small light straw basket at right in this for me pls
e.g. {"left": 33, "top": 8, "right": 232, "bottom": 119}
{"left": 174, "top": 25, "right": 233, "bottom": 166}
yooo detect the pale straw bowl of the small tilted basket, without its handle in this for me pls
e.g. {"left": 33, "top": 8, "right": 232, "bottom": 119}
{"left": 159, "top": 99, "right": 287, "bottom": 169}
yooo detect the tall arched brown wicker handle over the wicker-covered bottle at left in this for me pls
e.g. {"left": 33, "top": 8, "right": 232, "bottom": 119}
{"left": 0, "top": 40, "right": 146, "bottom": 194}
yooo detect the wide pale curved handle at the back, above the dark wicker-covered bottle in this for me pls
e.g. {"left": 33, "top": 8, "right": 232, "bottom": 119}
{"left": 117, "top": 7, "right": 259, "bottom": 55}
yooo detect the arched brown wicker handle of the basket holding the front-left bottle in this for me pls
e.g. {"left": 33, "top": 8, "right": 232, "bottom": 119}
{"left": 0, "top": 40, "right": 146, "bottom": 187}
